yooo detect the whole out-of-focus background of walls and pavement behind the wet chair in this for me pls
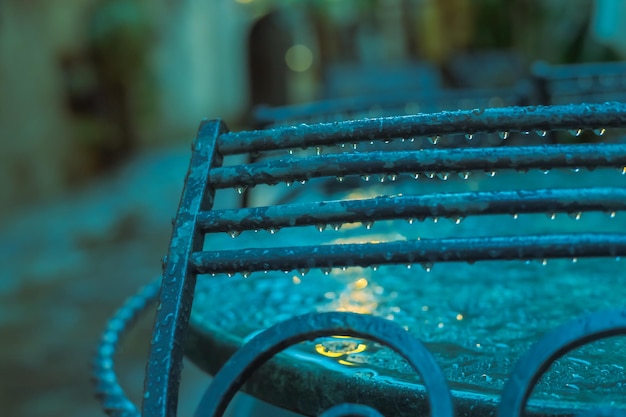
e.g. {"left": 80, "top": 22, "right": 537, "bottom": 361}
{"left": 0, "top": 0, "right": 626, "bottom": 417}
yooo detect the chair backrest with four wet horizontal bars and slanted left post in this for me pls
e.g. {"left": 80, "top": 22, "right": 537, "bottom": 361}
{"left": 142, "top": 103, "right": 626, "bottom": 416}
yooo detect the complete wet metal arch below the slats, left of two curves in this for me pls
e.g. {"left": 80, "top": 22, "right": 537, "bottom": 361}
{"left": 196, "top": 312, "right": 454, "bottom": 417}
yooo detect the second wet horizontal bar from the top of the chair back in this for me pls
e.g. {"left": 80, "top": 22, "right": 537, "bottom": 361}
{"left": 209, "top": 144, "right": 626, "bottom": 188}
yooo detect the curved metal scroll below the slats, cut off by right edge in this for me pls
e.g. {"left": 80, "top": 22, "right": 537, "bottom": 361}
{"left": 498, "top": 309, "right": 626, "bottom": 417}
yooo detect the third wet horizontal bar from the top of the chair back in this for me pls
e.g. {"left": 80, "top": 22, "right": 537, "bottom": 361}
{"left": 197, "top": 187, "right": 626, "bottom": 233}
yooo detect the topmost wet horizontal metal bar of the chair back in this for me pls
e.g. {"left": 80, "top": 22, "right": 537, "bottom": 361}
{"left": 213, "top": 102, "right": 626, "bottom": 155}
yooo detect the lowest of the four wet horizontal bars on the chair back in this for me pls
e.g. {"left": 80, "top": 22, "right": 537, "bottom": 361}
{"left": 191, "top": 233, "right": 626, "bottom": 274}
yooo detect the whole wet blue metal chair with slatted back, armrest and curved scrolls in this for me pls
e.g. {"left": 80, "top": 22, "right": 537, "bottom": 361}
{"left": 95, "top": 103, "right": 626, "bottom": 417}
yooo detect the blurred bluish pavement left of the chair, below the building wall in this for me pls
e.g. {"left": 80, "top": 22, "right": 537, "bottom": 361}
{"left": 0, "top": 147, "right": 219, "bottom": 417}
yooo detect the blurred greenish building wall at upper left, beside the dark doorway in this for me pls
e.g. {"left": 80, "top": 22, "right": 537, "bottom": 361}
{"left": 0, "top": 0, "right": 251, "bottom": 219}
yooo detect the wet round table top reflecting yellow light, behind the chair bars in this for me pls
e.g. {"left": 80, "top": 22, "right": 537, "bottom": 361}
{"left": 187, "top": 167, "right": 626, "bottom": 415}
